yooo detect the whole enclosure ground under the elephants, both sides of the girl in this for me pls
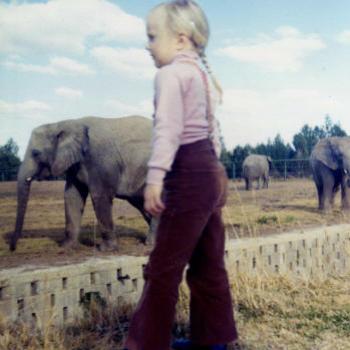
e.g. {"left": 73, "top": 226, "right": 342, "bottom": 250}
{"left": 0, "top": 179, "right": 350, "bottom": 268}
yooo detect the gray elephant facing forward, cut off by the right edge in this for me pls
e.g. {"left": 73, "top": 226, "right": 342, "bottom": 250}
{"left": 310, "top": 137, "right": 350, "bottom": 211}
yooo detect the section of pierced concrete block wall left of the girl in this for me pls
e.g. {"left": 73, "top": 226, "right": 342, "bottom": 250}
{"left": 0, "top": 256, "right": 147, "bottom": 325}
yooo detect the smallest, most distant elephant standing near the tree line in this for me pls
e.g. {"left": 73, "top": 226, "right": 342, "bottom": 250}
{"left": 242, "top": 154, "right": 272, "bottom": 191}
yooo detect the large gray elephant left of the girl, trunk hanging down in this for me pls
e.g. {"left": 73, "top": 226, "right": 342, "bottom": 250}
{"left": 9, "top": 116, "right": 152, "bottom": 250}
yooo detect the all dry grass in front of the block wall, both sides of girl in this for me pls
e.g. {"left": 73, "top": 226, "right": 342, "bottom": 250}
{"left": 0, "top": 275, "right": 350, "bottom": 350}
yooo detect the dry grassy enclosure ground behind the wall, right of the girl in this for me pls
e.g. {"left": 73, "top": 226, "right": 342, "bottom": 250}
{"left": 224, "top": 179, "right": 350, "bottom": 238}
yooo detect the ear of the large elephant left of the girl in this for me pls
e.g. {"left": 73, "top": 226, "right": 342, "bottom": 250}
{"left": 51, "top": 124, "right": 89, "bottom": 176}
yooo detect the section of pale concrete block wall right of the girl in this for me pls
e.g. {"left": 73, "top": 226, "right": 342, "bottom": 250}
{"left": 226, "top": 225, "right": 350, "bottom": 278}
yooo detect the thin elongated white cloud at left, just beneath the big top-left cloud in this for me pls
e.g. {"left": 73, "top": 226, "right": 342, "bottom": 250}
{"left": 2, "top": 57, "right": 95, "bottom": 75}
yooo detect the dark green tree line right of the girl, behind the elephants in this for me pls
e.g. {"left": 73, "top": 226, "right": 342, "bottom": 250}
{"left": 221, "top": 115, "right": 347, "bottom": 178}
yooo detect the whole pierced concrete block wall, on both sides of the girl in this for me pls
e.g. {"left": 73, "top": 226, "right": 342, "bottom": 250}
{"left": 0, "top": 225, "right": 350, "bottom": 325}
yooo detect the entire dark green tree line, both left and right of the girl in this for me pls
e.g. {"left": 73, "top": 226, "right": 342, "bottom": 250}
{"left": 0, "top": 116, "right": 347, "bottom": 181}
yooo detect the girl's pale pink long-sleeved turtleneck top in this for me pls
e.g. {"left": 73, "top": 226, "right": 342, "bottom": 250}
{"left": 146, "top": 51, "right": 220, "bottom": 184}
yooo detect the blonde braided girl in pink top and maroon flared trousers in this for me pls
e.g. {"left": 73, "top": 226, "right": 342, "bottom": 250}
{"left": 125, "top": 0, "right": 237, "bottom": 350}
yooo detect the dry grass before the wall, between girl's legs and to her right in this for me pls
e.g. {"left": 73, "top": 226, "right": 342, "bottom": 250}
{"left": 177, "top": 274, "right": 350, "bottom": 350}
